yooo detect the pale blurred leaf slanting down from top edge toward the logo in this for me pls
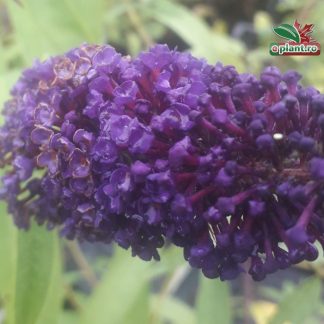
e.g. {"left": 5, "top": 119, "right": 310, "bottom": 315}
{"left": 141, "top": 0, "right": 244, "bottom": 68}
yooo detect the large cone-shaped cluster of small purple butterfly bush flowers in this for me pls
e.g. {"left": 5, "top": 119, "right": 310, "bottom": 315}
{"left": 0, "top": 45, "right": 324, "bottom": 280}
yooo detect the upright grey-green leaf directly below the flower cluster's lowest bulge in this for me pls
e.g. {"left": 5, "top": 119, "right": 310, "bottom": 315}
{"left": 196, "top": 274, "right": 233, "bottom": 324}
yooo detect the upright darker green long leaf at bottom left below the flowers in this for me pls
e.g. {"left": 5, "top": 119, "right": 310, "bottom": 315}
{"left": 7, "top": 224, "right": 61, "bottom": 324}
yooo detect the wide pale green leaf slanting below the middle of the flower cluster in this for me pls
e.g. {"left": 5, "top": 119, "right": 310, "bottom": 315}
{"left": 80, "top": 249, "right": 152, "bottom": 324}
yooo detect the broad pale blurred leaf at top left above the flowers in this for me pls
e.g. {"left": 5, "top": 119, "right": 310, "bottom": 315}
{"left": 6, "top": 0, "right": 105, "bottom": 64}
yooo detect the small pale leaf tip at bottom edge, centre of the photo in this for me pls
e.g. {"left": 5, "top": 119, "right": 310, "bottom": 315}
{"left": 151, "top": 295, "right": 194, "bottom": 324}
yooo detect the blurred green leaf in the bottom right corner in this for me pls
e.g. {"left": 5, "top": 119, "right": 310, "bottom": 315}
{"left": 270, "top": 277, "right": 321, "bottom": 324}
